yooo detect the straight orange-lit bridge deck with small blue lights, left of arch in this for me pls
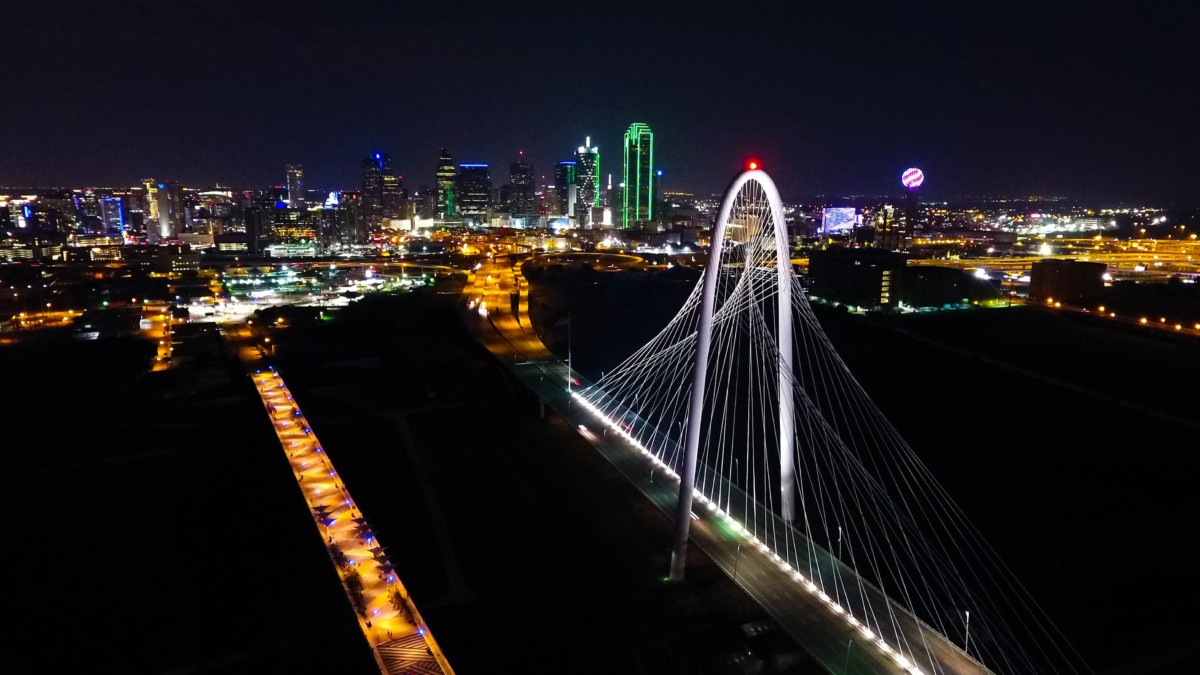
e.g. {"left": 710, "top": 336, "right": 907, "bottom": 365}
{"left": 253, "top": 368, "right": 454, "bottom": 675}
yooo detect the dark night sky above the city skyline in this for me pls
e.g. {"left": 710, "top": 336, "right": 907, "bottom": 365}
{"left": 0, "top": 0, "right": 1200, "bottom": 203}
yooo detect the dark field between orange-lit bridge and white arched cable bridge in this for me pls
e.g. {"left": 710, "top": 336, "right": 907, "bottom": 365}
{"left": 267, "top": 293, "right": 814, "bottom": 673}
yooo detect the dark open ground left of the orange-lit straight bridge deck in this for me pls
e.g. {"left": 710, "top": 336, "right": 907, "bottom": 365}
{"left": 0, "top": 335, "right": 374, "bottom": 673}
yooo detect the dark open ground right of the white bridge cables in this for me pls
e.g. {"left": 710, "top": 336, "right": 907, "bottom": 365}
{"left": 822, "top": 307, "right": 1200, "bottom": 673}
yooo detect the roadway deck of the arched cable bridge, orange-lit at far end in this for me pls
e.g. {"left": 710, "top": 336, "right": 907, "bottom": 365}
{"left": 463, "top": 253, "right": 990, "bottom": 675}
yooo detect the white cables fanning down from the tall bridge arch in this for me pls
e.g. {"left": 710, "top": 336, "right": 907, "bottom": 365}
{"left": 578, "top": 174, "right": 1087, "bottom": 674}
